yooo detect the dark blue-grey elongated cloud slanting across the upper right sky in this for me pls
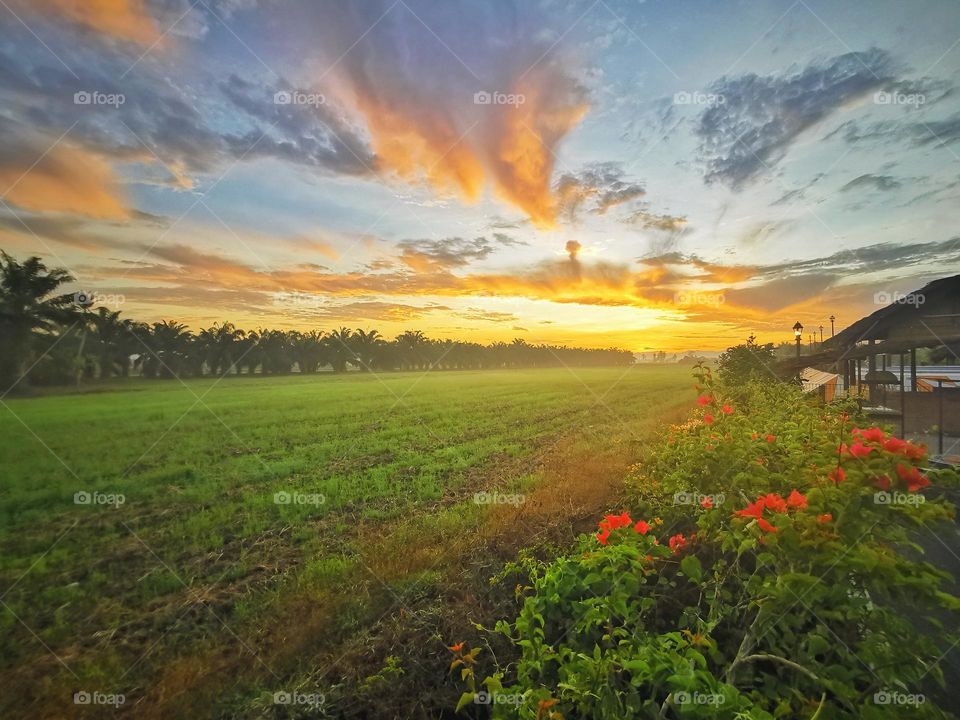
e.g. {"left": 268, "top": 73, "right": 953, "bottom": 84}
{"left": 696, "top": 48, "right": 894, "bottom": 190}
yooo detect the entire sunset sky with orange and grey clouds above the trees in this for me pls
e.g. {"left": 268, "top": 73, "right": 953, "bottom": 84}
{"left": 0, "top": 0, "right": 960, "bottom": 352}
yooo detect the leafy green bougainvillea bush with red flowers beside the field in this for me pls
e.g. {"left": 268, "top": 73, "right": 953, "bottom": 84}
{"left": 455, "top": 367, "right": 960, "bottom": 720}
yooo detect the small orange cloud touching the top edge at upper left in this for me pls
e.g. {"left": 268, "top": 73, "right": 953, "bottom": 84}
{"left": 16, "top": 0, "right": 161, "bottom": 45}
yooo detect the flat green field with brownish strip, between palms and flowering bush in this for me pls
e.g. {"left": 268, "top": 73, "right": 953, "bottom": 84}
{"left": 0, "top": 367, "right": 690, "bottom": 717}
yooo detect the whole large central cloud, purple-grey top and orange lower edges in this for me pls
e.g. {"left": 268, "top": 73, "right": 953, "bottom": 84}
{"left": 292, "top": 2, "right": 588, "bottom": 228}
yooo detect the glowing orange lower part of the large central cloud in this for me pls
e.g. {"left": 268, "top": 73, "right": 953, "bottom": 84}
{"left": 329, "top": 54, "right": 589, "bottom": 229}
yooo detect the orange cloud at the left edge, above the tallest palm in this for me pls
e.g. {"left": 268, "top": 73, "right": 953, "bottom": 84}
{"left": 0, "top": 139, "right": 129, "bottom": 219}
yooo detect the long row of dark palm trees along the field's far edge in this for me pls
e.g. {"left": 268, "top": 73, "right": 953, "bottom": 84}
{"left": 0, "top": 251, "right": 634, "bottom": 394}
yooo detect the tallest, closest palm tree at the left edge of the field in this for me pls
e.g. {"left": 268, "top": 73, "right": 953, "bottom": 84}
{"left": 0, "top": 251, "right": 79, "bottom": 392}
